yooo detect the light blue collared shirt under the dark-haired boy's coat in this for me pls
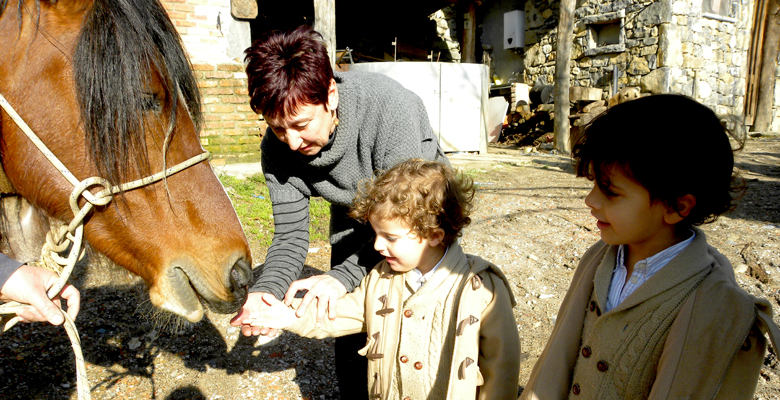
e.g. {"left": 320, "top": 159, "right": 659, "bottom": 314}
{"left": 605, "top": 231, "right": 696, "bottom": 311}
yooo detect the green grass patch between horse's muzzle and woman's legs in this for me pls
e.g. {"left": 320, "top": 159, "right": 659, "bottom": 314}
{"left": 219, "top": 174, "right": 330, "bottom": 247}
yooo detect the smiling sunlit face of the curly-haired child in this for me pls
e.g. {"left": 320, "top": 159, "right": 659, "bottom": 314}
{"left": 368, "top": 216, "right": 444, "bottom": 274}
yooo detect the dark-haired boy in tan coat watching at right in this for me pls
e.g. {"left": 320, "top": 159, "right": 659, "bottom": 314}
{"left": 522, "top": 95, "right": 780, "bottom": 400}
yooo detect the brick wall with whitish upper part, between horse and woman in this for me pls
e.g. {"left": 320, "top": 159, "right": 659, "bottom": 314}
{"left": 162, "top": 0, "right": 266, "bottom": 165}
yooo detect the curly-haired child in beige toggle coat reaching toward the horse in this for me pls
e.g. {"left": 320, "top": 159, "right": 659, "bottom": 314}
{"left": 247, "top": 159, "right": 520, "bottom": 400}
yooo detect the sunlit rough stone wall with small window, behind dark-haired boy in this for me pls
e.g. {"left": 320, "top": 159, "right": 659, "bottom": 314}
{"left": 525, "top": 0, "right": 753, "bottom": 119}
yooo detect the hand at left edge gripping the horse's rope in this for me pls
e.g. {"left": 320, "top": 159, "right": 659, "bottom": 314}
{"left": 0, "top": 265, "right": 81, "bottom": 325}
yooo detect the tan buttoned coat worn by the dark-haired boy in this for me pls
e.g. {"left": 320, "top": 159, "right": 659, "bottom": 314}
{"left": 521, "top": 229, "right": 780, "bottom": 400}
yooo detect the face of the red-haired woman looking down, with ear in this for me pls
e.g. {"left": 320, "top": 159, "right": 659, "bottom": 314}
{"left": 266, "top": 81, "right": 338, "bottom": 156}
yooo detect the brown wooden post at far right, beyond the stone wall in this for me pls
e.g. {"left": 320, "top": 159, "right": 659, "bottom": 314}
{"left": 753, "top": 0, "right": 780, "bottom": 132}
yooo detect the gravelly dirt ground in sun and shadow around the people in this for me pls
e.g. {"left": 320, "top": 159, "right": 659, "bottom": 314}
{"left": 0, "top": 137, "right": 780, "bottom": 400}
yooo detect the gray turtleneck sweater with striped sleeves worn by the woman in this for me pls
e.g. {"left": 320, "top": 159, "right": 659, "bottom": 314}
{"left": 251, "top": 72, "right": 449, "bottom": 299}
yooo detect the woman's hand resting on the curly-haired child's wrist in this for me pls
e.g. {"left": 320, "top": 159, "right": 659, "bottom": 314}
{"left": 284, "top": 275, "right": 347, "bottom": 326}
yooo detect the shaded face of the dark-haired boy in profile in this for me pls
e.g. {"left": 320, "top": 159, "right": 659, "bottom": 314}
{"left": 585, "top": 168, "right": 676, "bottom": 257}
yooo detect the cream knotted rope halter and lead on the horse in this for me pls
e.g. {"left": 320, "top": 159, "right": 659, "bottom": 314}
{"left": 0, "top": 94, "right": 209, "bottom": 400}
